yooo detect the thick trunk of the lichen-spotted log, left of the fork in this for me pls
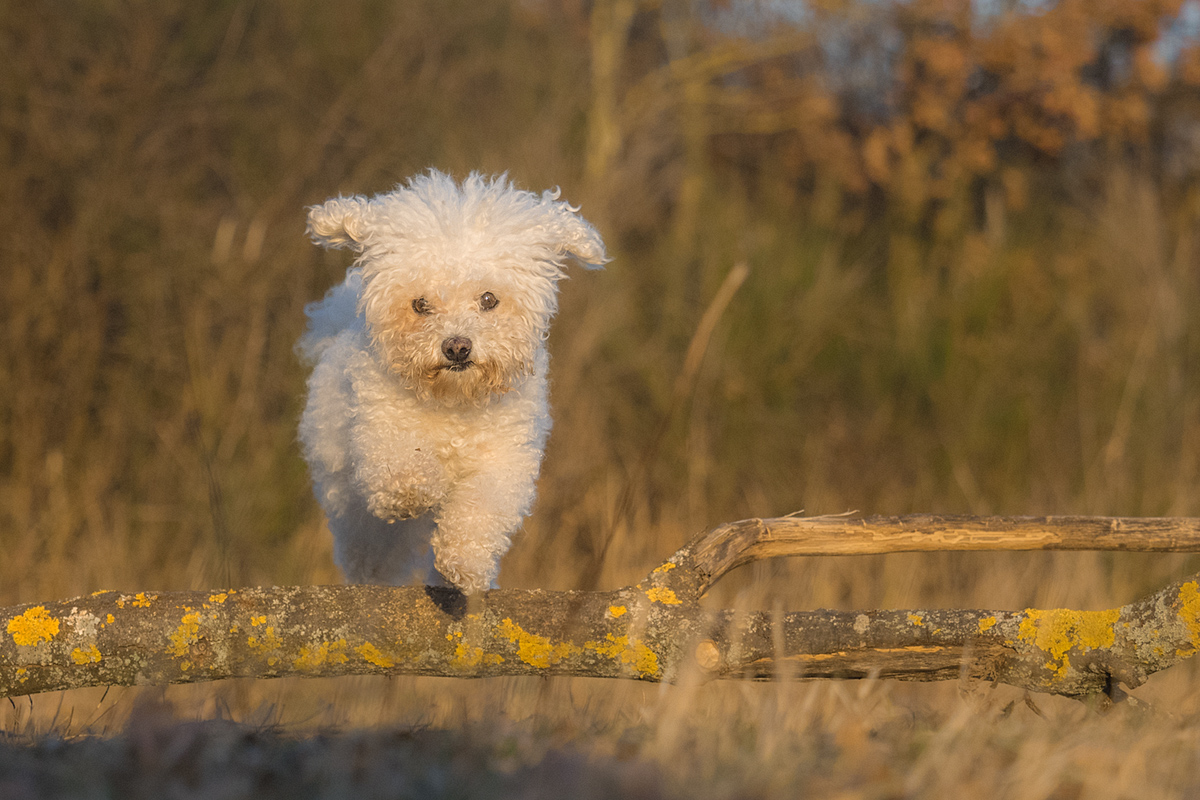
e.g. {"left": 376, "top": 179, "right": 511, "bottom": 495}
{"left": 0, "top": 585, "right": 696, "bottom": 696}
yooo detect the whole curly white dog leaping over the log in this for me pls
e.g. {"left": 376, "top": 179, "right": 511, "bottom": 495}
{"left": 299, "top": 170, "right": 607, "bottom": 593}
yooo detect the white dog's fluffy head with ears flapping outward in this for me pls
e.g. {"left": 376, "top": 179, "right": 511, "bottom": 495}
{"left": 308, "top": 170, "right": 607, "bottom": 405}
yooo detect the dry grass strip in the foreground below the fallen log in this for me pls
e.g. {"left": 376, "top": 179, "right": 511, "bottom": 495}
{"left": 7, "top": 675, "right": 1200, "bottom": 799}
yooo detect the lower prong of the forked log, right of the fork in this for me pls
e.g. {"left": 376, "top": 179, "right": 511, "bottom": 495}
{"left": 708, "top": 577, "right": 1200, "bottom": 698}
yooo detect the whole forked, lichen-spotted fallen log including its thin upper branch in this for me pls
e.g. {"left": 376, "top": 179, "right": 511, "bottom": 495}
{"left": 0, "top": 517, "right": 1200, "bottom": 697}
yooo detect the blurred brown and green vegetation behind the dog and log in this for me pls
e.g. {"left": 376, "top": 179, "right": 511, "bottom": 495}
{"left": 0, "top": 0, "right": 1200, "bottom": 623}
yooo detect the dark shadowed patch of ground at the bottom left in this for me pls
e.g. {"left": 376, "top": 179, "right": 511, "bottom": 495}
{"left": 0, "top": 721, "right": 666, "bottom": 800}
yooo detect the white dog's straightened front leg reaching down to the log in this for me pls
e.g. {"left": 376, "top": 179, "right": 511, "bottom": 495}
{"left": 433, "top": 453, "right": 538, "bottom": 594}
